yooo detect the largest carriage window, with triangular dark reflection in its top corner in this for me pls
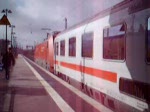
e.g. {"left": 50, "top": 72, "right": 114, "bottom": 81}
{"left": 103, "top": 24, "right": 126, "bottom": 60}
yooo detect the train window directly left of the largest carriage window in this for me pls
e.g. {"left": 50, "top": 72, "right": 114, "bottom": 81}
{"left": 82, "top": 32, "right": 93, "bottom": 58}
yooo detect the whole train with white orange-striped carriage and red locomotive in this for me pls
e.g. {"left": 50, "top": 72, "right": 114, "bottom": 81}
{"left": 34, "top": 0, "right": 150, "bottom": 112}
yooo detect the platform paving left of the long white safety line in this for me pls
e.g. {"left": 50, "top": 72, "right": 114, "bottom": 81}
{"left": 0, "top": 57, "right": 59, "bottom": 112}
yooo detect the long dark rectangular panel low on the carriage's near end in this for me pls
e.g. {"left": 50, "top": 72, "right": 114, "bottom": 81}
{"left": 119, "top": 77, "right": 150, "bottom": 102}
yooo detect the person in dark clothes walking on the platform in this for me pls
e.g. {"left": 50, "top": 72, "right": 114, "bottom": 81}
{"left": 2, "top": 48, "right": 15, "bottom": 80}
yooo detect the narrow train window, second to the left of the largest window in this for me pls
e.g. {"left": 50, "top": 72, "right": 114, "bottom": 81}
{"left": 69, "top": 37, "right": 76, "bottom": 56}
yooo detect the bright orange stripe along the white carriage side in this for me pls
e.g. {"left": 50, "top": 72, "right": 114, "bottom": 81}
{"left": 60, "top": 62, "right": 117, "bottom": 83}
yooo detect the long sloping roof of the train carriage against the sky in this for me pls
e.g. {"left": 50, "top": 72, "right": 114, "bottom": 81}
{"left": 57, "top": 0, "right": 150, "bottom": 36}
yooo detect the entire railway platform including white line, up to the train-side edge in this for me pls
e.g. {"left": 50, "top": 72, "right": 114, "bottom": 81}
{"left": 0, "top": 55, "right": 112, "bottom": 112}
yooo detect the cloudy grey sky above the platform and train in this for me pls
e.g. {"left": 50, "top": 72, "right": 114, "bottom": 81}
{"left": 0, "top": 0, "right": 123, "bottom": 48}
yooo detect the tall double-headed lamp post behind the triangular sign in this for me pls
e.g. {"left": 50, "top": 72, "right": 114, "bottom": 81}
{"left": 2, "top": 9, "right": 12, "bottom": 80}
